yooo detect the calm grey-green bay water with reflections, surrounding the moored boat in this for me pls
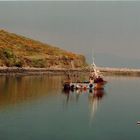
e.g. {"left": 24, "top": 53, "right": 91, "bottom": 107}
{"left": 0, "top": 76, "right": 140, "bottom": 140}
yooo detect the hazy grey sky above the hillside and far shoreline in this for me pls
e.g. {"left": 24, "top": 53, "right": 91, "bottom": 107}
{"left": 0, "top": 1, "right": 140, "bottom": 68}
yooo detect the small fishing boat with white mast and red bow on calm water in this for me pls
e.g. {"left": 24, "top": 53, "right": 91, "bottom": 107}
{"left": 63, "top": 55, "right": 107, "bottom": 90}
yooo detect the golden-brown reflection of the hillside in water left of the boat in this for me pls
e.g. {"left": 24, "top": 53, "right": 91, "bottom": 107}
{"left": 0, "top": 76, "right": 62, "bottom": 107}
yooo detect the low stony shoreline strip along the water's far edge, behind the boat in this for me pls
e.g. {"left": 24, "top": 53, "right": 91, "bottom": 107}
{"left": 0, "top": 67, "right": 140, "bottom": 76}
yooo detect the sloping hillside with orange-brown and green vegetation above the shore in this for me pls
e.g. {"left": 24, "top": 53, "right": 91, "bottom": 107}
{"left": 0, "top": 30, "right": 87, "bottom": 68}
